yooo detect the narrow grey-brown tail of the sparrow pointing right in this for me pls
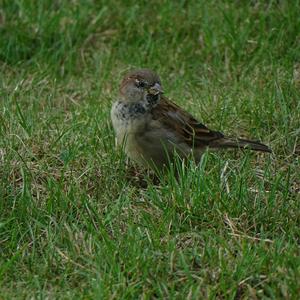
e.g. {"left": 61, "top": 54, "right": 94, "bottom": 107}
{"left": 210, "top": 137, "right": 272, "bottom": 153}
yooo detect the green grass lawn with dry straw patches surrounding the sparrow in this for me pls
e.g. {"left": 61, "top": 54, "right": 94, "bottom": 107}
{"left": 0, "top": 0, "right": 300, "bottom": 299}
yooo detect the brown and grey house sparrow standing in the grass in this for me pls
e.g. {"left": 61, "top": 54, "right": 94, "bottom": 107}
{"left": 111, "top": 69, "right": 271, "bottom": 169}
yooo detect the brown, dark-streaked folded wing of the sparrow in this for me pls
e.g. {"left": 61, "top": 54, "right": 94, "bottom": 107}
{"left": 152, "top": 97, "right": 224, "bottom": 147}
